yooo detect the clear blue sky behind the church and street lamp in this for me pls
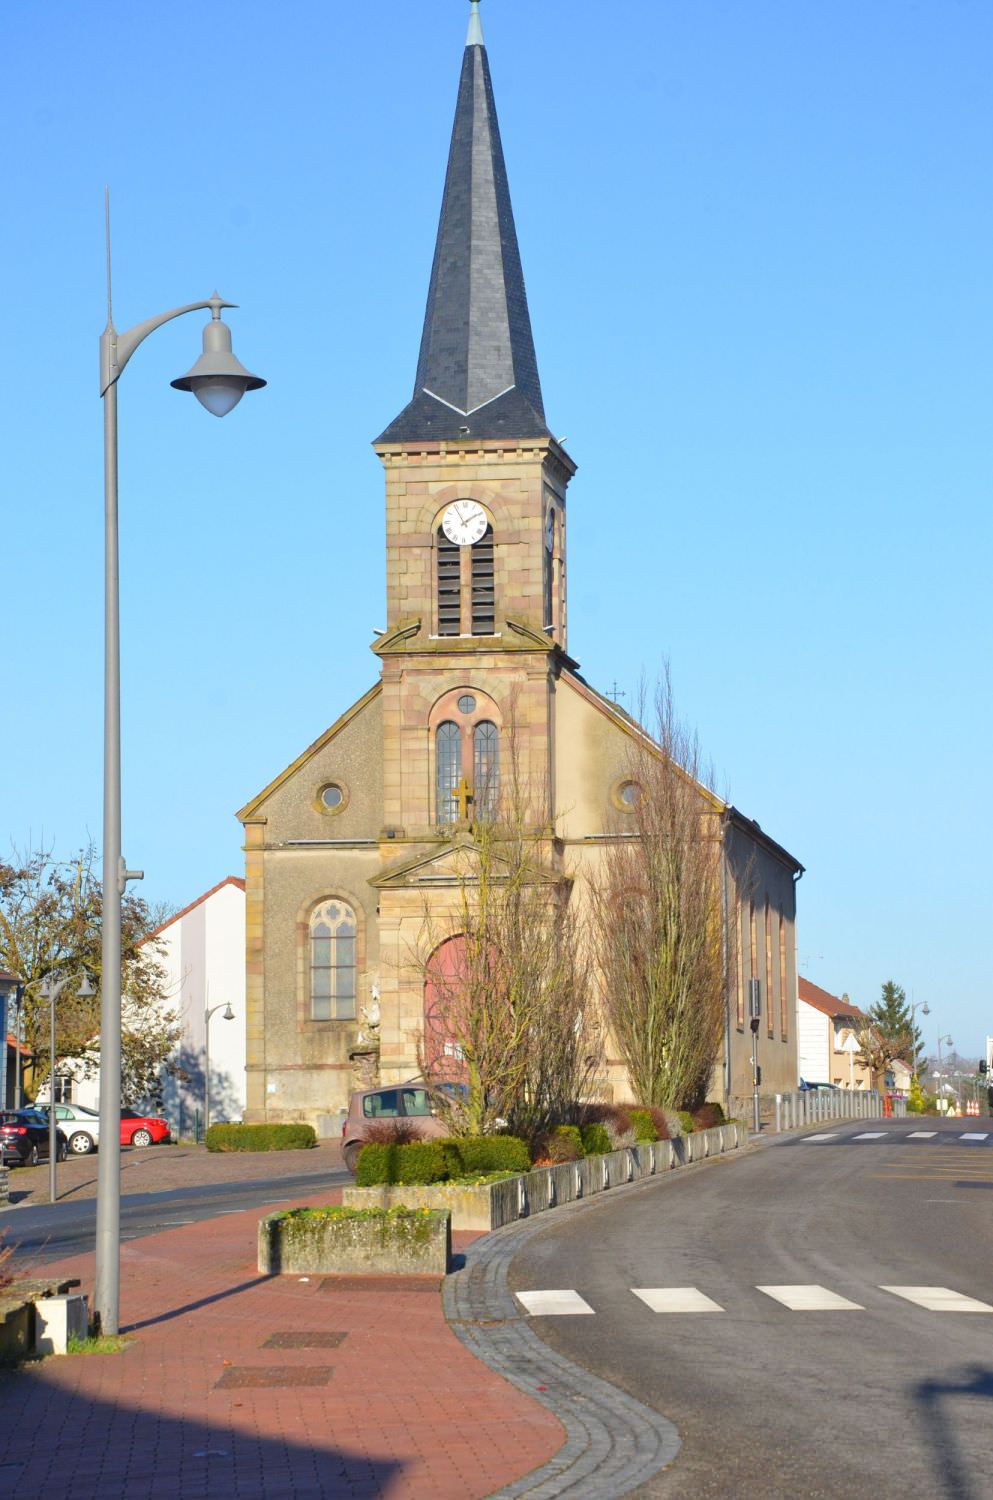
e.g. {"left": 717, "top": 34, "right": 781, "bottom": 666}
{"left": 0, "top": 0, "right": 993, "bottom": 1055}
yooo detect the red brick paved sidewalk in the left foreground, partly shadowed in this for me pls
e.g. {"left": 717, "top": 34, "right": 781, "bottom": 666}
{"left": 0, "top": 1193, "right": 564, "bottom": 1500}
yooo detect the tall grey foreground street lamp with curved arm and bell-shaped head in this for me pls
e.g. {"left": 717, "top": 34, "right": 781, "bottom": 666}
{"left": 95, "top": 200, "right": 266, "bottom": 1334}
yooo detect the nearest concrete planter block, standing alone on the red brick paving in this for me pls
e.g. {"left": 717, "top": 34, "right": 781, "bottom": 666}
{"left": 258, "top": 1206, "right": 452, "bottom": 1277}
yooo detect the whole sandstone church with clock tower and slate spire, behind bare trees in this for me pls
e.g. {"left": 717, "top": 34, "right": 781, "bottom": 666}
{"left": 239, "top": 0, "right": 803, "bottom": 1124}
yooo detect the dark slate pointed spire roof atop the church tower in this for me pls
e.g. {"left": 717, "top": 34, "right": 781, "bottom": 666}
{"left": 378, "top": 0, "right": 551, "bottom": 443}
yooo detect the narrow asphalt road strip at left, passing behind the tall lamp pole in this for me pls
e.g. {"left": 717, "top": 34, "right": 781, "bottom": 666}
{"left": 0, "top": 1169, "right": 353, "bottom": 1266}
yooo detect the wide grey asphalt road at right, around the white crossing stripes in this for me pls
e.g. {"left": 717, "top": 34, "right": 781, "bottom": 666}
{"left": 510, "top": 1119, "right": 993, "bottom": 1500}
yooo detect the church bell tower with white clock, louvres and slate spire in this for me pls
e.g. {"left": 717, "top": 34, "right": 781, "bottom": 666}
{"left": 374, "top": 0, "right": 575, "bottom": 857}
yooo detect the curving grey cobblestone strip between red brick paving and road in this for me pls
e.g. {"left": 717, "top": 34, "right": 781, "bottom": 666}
{"left": 444, "top": 1182, "right": 680, "bottom": 1500}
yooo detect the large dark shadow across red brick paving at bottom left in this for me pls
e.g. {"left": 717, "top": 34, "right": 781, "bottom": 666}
{"left": 0, "top": 1374, "right": 405, "bottom": 1500}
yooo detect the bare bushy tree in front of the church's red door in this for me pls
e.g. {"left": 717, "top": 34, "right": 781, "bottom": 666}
{"left": 419, "top": 735, "right": 602, "bottom": 1140}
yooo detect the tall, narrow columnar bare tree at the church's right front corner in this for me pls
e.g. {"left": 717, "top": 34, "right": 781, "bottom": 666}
{"left": 590, "top": 668, "right": 737, "bottom": 1109}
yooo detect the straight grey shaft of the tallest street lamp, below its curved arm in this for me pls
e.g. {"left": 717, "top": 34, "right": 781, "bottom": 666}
{"left": 95, "top": 381, "right": 122, "bottom": 1334}
